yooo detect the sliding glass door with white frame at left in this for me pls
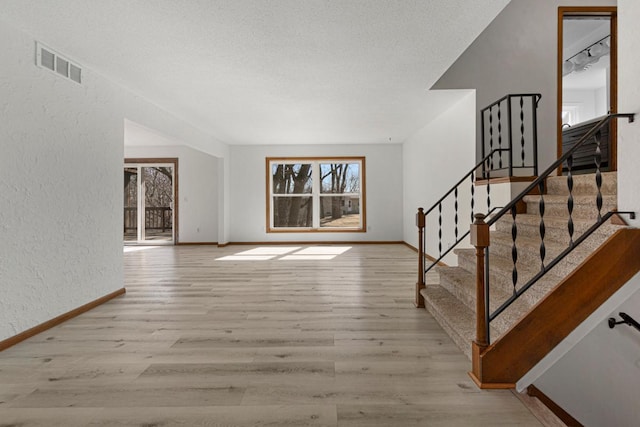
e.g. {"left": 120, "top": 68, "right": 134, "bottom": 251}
{"left": 124, "top": 164, "right": 175, "bottom": 244}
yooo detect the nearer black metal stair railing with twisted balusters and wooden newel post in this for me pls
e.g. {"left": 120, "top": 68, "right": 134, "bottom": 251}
{"left": 471, "top": 114, "right": 635, "bottom": 352}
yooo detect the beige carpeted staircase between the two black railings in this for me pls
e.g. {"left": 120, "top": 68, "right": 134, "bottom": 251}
{"left": 420, "top": 172, "right": 622, "bottom": 359}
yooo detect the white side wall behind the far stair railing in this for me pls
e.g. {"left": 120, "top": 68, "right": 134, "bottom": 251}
{"left": 402, "top": 91, "right": 476, "bottom": 265}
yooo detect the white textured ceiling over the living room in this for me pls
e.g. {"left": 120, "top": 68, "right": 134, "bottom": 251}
{"left": 0, "top": 0, "right": 509, "bottom": 144}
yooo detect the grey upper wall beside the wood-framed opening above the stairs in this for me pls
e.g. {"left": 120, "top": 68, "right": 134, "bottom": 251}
{"left": 433, "top": 0, "right": 622, "bottom": 171}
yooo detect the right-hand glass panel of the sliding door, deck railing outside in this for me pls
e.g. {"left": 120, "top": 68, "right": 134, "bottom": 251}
{"left": 141, "top": 166, "right": 173, "bottom": 241}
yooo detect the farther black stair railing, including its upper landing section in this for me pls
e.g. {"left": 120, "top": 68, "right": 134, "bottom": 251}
{"left": 415, "top": 93, "right": 542, "bottom": 307}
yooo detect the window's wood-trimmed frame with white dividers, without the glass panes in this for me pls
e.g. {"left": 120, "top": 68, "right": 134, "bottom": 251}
{"left": 265, "top": 156, "right": 367, "bottom": 233}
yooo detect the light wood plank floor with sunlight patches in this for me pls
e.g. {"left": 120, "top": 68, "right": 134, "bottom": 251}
{"left": 0, "top": 245, "right": 540, "bottom": 427}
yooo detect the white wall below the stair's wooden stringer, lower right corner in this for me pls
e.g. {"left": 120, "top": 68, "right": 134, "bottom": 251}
{"left": 535, "top": 274, "right": 640, "bottom": 426}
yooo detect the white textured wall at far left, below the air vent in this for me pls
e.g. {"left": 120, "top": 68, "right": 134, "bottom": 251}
{"left": 0, "top": 22, "right": 123, "bottom": 339}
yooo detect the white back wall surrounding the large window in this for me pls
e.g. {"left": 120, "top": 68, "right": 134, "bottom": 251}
{"left": 229, "top": 144, "right": 402, "bottom": 242}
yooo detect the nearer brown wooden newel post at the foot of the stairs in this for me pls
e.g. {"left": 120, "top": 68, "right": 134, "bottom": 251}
{"left": 470, "top": 213, "right": 489, "bottom": 382}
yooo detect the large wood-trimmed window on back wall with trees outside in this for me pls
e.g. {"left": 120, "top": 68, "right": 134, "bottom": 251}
{"left": 267, "top": 157, "right": 366, "bottom": 232}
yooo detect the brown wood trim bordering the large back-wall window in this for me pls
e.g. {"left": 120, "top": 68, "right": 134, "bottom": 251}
{"left": 265, "top": 156, "right": 367, "bottom": 234}
